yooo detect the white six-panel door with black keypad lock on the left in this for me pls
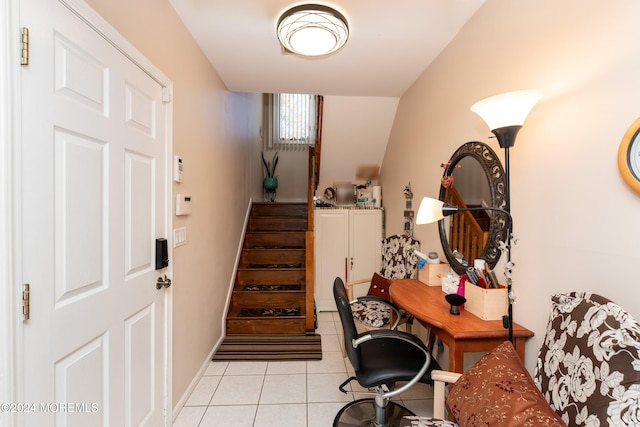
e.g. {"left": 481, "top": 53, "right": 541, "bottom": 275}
{"left": 20, "top": 0, "right": 171, "bottom": 427}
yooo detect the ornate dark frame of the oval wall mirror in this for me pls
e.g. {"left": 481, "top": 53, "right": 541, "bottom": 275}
{"left": 438, "top": 141, "right": 508, "bottom": 275}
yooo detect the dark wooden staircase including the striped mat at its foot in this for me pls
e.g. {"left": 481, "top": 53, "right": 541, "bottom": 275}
{"left": 213, "top": 203, "right": 322, "bottom": 360}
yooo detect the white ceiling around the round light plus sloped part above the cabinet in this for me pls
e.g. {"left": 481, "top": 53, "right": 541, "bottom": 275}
{"left": 169, "top": 0, "right": 485, "bottom": 185}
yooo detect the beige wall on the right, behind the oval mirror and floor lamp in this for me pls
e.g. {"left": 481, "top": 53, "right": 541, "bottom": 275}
{"left": 381, "top": 0, "right": 640, "bottom": 369}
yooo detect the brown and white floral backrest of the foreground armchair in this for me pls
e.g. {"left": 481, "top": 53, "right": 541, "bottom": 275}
{"left": 534, "top": 292, "right": 640, "bottom": 426}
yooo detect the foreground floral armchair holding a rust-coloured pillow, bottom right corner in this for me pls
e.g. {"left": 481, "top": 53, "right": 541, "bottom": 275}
{"left": 401, "top": 292, "right": 640, "bottom": 427}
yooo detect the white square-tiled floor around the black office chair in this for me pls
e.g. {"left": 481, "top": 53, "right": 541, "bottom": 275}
{"left": 173, "top": 312, "right": 433, "bottom": 427}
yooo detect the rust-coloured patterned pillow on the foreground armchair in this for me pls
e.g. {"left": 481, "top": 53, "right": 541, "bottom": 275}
{"left": 446, "top": 341, "right": 565, "bottom": 427}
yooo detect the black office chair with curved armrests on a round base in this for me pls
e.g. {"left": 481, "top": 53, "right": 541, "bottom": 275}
{"left": 333, "top": 277, "right": 440, "bottom": 427}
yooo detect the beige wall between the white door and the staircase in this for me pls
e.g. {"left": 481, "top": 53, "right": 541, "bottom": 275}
{"left": 88, "top": 0, "right": 261, "bottom": 405}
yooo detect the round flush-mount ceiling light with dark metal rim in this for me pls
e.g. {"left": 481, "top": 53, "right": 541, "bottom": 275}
{"left": 277, "top": 4, "right": 349, "bottom": 56}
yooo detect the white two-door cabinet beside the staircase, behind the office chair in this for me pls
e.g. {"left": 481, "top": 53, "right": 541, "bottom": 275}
{"left": 314, "top": 209, "right": 382, "bottom": 311}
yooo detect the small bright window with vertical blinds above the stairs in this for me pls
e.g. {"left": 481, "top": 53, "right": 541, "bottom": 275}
{"left": 264, "top": 93, "right": 320, "bottom": 151}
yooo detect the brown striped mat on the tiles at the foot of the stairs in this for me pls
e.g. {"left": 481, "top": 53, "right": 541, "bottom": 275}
{"left": 213, "top": 334, "right": 322, "bottom": 360}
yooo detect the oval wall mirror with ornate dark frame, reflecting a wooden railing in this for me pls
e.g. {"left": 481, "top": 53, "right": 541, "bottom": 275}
{"left": 438, "top": 141, "right": 508, "bottom": 274}
